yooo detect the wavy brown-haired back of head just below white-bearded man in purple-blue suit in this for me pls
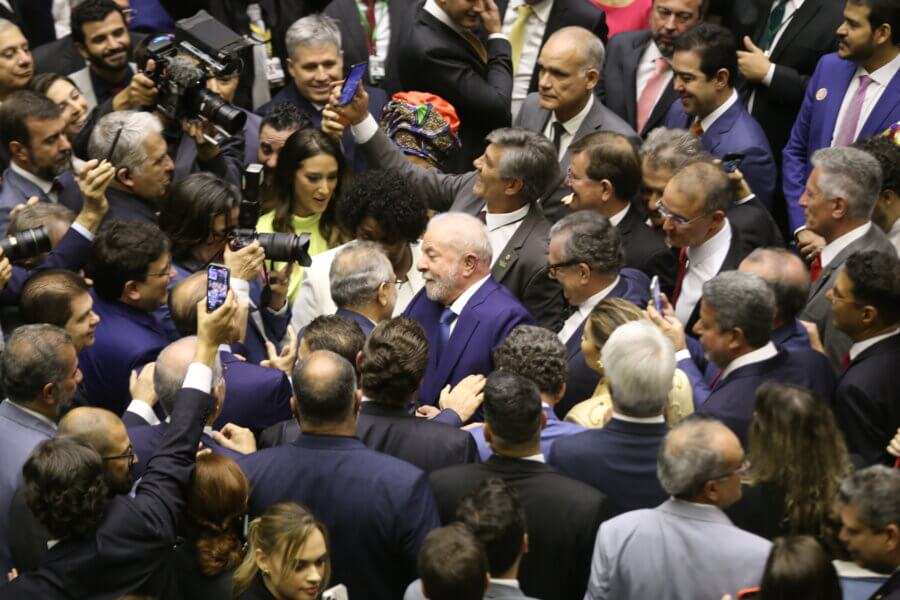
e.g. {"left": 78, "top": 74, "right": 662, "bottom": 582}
{"left": 359, "top": 317, "right": 428, "bottom": 407}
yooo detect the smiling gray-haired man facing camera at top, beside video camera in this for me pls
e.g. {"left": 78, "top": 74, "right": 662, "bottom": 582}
{"left": 256, "top": 14, "right": 387, "bottom": 173}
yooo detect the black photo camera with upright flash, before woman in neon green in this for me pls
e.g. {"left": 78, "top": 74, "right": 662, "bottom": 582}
{"left": 229, "top": 163, "right": 312, "bottom": 267}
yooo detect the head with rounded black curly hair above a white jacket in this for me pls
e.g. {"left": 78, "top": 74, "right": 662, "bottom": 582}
{"left": 337, "top": 171, "right": 428, "bottom": 270}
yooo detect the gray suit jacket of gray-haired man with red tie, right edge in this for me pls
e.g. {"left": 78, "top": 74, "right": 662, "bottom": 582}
{"left": 800, "top": 224, "right": 897, "bottom": 371}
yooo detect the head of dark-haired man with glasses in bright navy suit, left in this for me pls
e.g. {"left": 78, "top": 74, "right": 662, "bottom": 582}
{"left": 88, "top": 221, "right": 174, "bottom": 312}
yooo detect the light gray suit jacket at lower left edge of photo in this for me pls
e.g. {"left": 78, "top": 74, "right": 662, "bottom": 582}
{"left": 0, "top": 400, "right": 56, "bottom": 572}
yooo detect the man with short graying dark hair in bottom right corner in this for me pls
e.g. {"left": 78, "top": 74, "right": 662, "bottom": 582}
{"left": 837, "top": 465, "right": 900, "bottom": 600}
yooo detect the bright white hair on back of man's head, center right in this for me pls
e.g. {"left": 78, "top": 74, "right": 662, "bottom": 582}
{"left": 600, "top": 320, "right": 675, "bottom": 418}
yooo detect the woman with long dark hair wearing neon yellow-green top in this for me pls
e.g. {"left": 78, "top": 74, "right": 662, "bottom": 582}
{"left": 256, "top": 128, "right": 350, "bottom": 300}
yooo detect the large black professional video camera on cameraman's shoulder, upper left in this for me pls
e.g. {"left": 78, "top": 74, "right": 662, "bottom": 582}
{"left": 146, "top": 10, "right": 253, "bottom": 135}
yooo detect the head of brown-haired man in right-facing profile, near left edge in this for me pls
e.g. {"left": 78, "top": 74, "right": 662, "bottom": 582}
{"left": 19, "top": 269, "right": 100, "bottom": 352}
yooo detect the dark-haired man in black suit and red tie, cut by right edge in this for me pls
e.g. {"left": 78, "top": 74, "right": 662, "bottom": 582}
{"left": 827, "top": 250, "right": 900, "bottom": 466}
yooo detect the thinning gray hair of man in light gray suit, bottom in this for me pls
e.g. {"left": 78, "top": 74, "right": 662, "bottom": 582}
{"left": 656, "top": 417, "right": 727, "bottom": 500}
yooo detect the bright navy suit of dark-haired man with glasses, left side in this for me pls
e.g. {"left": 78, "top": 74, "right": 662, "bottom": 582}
{"left": 78, "top": 290, "right": 178, "bottom": 415}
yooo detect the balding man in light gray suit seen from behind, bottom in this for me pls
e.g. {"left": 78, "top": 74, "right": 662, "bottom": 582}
{"left": 584, "top": 418, "right": 772, "bottom": 600}
